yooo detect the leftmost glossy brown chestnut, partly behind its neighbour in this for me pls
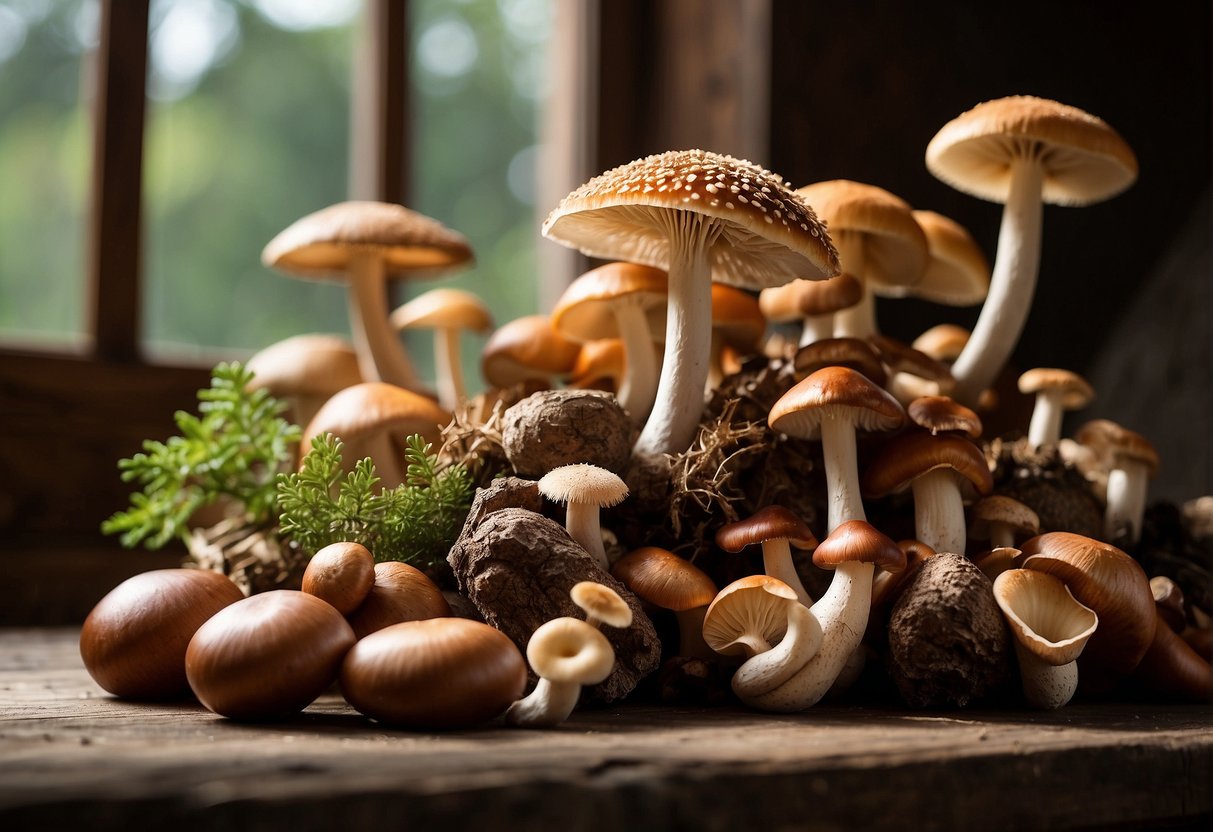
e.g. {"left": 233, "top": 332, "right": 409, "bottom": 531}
{"left": 80, "top": 569, "right": 244, "bottom": 700}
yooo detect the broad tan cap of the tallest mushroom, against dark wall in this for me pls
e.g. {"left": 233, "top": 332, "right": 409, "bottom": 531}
{"left": 927, "top": 96, "right": 1138, "bottom": 205}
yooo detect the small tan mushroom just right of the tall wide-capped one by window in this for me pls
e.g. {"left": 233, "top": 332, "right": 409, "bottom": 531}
{"left": 389, "top": 289, "right": 492, "bottom": 410}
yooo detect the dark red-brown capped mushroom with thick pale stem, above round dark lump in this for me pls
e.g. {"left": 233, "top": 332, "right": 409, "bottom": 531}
{"left": 864, "top": 431, "right": 993, "bottom": 554}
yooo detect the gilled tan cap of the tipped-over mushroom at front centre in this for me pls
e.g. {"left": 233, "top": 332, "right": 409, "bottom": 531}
{"left": 704, "top": 575, "right": 801, "bottom": 656}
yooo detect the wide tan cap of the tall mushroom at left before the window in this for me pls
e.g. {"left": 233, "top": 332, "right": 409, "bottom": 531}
{"left": 261, "top": 201, "right": 472, "bottom": 278}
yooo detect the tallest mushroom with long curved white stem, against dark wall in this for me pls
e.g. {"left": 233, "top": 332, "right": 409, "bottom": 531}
{"left": 927, "top": 96, "right": 1138, "bottom": 406}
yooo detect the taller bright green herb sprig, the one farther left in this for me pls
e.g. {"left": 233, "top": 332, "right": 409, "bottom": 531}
{"left": 101, "top": 361, "right": 300, "bottom": 548}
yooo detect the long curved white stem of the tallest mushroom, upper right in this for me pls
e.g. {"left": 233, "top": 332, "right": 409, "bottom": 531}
{"left": 952, "top": 156, "right": 1043, "bottom": 408}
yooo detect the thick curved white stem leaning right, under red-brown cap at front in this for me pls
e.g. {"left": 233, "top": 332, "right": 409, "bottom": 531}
{"left": 746, "top": 562, "right": 875, "bottom": 713}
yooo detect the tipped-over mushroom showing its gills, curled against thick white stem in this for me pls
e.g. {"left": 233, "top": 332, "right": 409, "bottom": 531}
{"left": 704, "top": 575, "right": 821, "bottom": 705}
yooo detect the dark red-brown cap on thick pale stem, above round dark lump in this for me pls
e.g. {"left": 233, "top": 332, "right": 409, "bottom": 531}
{"left": 862, "top": 431, "right": 993, "bottom": 497}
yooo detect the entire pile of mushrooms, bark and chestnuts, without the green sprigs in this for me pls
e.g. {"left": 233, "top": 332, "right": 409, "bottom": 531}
{"left": 81, "top": 96, "right": 1213, "bottom": 728}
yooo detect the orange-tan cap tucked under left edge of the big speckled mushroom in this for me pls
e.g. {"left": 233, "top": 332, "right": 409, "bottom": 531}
{"left": 552, "top": 262, "right": 670, "bottom": 342}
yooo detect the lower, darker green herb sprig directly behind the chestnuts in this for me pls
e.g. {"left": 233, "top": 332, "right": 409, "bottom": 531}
{"left": 278, "top": 433, "right": 472, "bottom": 566}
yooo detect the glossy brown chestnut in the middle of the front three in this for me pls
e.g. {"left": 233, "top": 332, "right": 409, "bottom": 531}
{"left": 186, "top": 589, "right": 354, "bottom": 719}
